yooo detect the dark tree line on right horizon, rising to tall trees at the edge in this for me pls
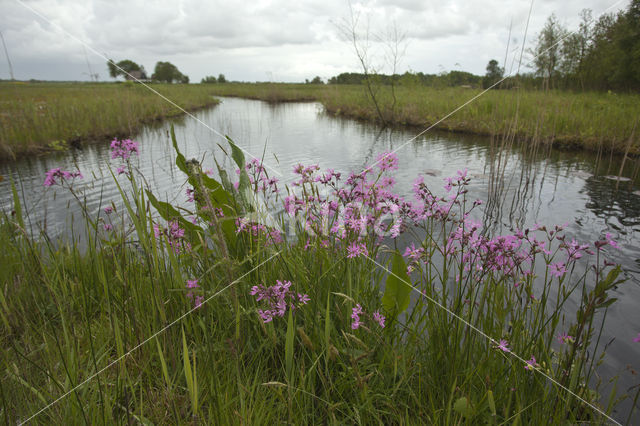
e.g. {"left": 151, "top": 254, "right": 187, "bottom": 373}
{"left": 328, "top": 0, "right": 640, "bottom": 91}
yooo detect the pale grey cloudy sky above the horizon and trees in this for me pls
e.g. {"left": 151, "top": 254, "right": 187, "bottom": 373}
{"left": 0, "top": 0, "right": 628, "bottom": 82}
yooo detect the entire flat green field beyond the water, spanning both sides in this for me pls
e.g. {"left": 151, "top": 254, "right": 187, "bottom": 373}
{"left": 0, "top": 82, "right": 640, "bottom": 159}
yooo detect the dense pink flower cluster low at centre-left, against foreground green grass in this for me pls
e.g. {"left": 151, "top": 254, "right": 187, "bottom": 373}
{"left": 249, "top": 280, "right": 311, "bottom": 323}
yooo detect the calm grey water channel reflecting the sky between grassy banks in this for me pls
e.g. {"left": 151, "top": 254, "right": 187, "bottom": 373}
{"left": 0, "top": 98, "right": 640, "bottom": 420}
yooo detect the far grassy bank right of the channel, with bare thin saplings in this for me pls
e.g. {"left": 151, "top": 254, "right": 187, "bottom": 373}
{"left": 212, "top": 84, "right": 640, "bottom": 154}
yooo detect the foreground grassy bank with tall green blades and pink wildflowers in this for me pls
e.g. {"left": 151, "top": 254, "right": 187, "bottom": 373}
{"left": 0, "top": 131, "right": 631, "bottom": 424}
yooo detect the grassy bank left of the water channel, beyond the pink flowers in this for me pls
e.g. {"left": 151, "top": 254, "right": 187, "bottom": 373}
{"left": 0, "top": 82, "right": 216, "bottom": 160}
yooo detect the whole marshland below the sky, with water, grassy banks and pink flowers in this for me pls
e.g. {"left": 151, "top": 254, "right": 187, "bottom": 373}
{"left": 0, "top": 2, "right": 640, "bottom": 424}
